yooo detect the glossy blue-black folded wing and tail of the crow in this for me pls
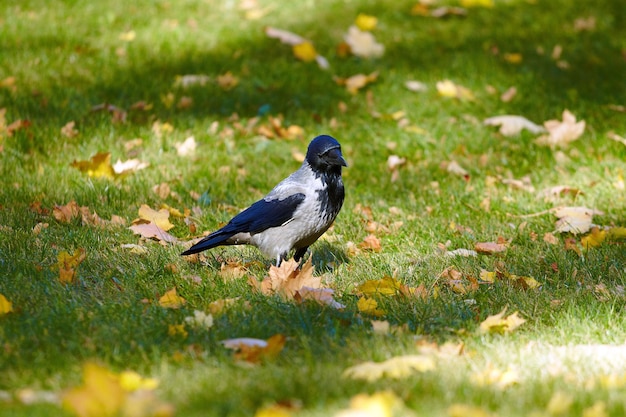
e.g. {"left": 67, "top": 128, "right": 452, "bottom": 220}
{"left": 182, "top": 193, "right": 304, "bottom": 255}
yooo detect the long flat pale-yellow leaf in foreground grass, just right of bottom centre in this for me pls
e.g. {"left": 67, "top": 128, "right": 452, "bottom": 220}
{"left": 343, "top": 355, "right": 435, "bottom": 382}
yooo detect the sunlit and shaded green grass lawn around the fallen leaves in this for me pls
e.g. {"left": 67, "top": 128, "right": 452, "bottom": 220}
{"left": 0, "top": 0, "right": 626, "bottom": 416}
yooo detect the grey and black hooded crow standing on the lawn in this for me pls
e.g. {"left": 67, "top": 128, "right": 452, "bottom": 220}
{"left": 182, "top": 135, "right": 348, "bottom": 265}
